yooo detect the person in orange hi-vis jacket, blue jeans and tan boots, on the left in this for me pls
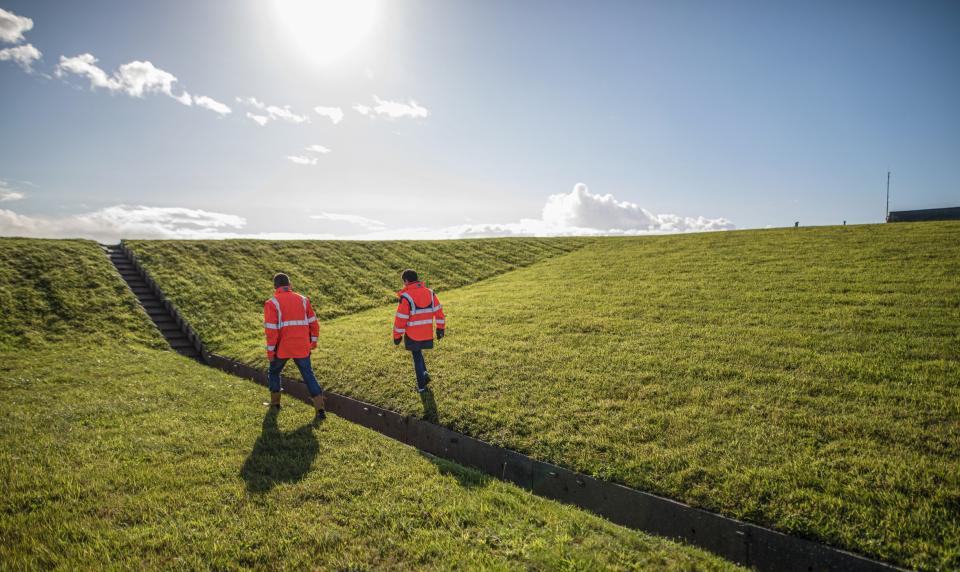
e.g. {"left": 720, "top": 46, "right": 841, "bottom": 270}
{"left": 263, "top": 274, "right": 325, "bottom": 419}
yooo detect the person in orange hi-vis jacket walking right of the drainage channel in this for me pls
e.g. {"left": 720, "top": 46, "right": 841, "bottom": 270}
{"left": 393, "top": 269, "right": 446, "bottom": 393}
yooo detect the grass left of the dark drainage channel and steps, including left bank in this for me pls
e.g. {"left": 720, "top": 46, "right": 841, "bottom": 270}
{"left": 0, "top": 239, "right": 728, "bottom": 569}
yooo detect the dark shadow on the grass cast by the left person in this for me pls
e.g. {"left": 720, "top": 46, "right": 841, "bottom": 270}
{"left": 240, "top": 407, "right": 320, "bottom": 493}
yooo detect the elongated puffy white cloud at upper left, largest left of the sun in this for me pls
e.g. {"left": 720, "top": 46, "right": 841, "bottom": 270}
{"left": 55, "top": 54, "right": 192, "bottom": 105}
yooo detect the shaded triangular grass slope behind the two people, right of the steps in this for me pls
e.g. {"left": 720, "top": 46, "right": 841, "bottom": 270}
{"left": 127, "top": 238, "right": 589, "bottom": 353}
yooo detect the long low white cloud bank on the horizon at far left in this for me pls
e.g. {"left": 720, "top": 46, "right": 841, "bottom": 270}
{"left": 0, "top": 205, "right": 247, "bottom": 242}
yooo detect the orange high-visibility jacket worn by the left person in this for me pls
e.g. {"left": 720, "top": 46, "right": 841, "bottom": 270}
{"left": 263, "top": 286, "right": 320, "bottom": 360}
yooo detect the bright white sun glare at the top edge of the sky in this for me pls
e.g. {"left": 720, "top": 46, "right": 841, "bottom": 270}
{"left": 273, "top": 0, "right": 376, "bottom": 64}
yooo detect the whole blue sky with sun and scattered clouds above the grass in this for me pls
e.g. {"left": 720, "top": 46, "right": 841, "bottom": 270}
{"left": 0, "top": 0, "right": 960, "bottom": 241}
